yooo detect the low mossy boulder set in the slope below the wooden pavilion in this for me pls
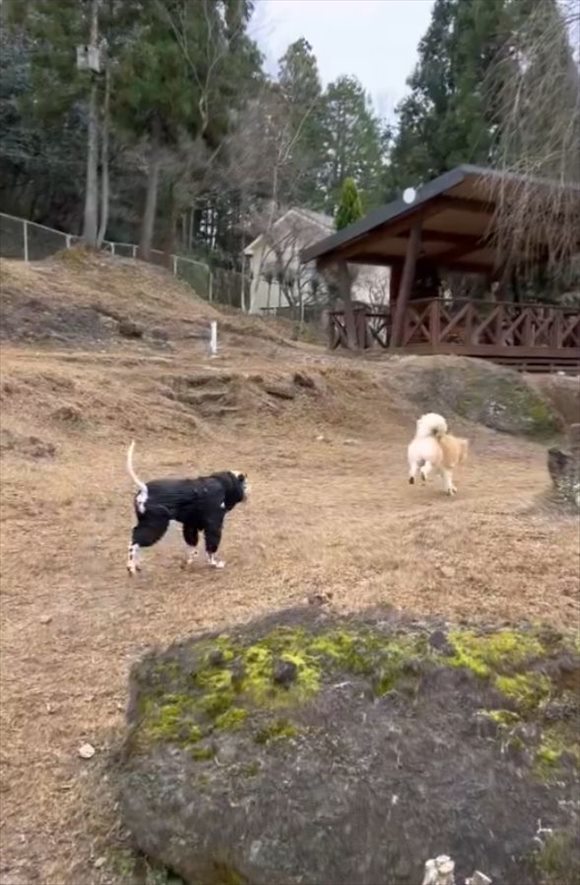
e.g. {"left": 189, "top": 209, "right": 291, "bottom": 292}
{"left": 389, "top": 356, "right": 563, "bottom": 440}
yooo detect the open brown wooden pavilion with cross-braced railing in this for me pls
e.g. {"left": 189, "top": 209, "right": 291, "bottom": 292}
{"left": 302, "top": 165, "right": 580, "bottom": 374}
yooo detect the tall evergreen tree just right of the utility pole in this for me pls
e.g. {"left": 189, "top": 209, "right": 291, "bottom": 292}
{"left": 112, "top": 0, "right": 260, "bottom": 256}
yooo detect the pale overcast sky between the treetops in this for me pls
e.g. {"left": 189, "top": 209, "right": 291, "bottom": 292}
{"left": 252, "top": 0, "right": 434, "bottom": 116}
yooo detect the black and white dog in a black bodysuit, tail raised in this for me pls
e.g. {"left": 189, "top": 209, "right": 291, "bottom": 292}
{"left": 127, "top": 442, "right": 247, "bottom": 575}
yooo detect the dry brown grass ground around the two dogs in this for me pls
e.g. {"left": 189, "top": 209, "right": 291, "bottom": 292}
{"left": 0, "top": 252, "right": 578, "bottom": 885}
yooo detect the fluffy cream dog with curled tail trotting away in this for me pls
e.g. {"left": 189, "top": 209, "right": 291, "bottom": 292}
{"left": 407, "top": 412, "right": 469, "bottom": 495}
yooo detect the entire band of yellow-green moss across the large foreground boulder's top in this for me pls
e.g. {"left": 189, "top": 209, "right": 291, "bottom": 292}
{"left": 131, "top": 622, "right": 580, "bottom": 778}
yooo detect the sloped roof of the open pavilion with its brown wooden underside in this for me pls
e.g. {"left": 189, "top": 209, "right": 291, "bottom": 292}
{"left": 301, "top": 165, "right": 580, "bottom": 270}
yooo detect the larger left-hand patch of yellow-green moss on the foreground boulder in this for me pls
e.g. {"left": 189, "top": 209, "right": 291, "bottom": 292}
{"left": 133, "top": 627, "right": 433, "bottom": 759}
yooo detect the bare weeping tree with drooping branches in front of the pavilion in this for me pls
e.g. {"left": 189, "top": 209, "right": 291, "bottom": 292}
{"left": 488, "top": 0, "right": 580, "bottom": 275}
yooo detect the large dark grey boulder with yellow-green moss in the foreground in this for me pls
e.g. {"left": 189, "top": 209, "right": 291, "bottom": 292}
{"left": 118, "top": 609, "right": 580, "bottom": 885}
